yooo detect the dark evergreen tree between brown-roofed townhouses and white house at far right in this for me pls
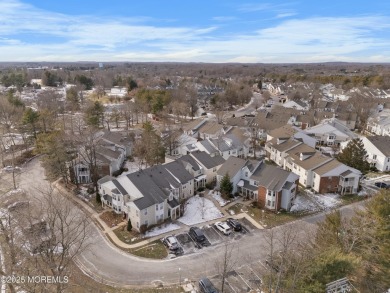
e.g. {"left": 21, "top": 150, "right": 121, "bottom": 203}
{"left": 337, "top": 138, "right": 370, "bottom": 174}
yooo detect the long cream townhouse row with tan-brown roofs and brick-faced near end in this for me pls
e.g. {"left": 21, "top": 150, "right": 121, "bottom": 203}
{"left": 265, "top": 130, "right": 361, "bottom": 194}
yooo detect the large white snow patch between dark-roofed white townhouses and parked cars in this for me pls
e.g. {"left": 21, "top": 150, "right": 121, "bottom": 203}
{"left": 178, "top": 195, "right": 223, "bottom": 225}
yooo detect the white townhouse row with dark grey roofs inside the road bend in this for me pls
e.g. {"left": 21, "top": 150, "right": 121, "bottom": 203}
{"left": 98, "top": 152, "right": 225, "bottom": 231}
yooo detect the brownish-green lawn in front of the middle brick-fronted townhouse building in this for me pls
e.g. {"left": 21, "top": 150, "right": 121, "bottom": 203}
{"left": 247, "top": 206, "right": 304, "bottom": 228}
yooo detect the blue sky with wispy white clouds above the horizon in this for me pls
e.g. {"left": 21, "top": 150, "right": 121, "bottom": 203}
{"left": 0, "top": 0, "right": 390, "bottom": 63}
